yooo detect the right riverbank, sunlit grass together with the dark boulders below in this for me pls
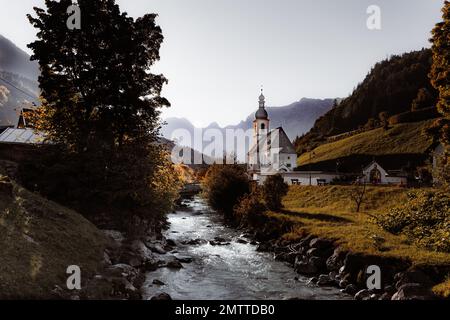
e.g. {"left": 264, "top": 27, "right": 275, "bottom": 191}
{"left": 248, "top": 186, "right": 450, "bottom": 299}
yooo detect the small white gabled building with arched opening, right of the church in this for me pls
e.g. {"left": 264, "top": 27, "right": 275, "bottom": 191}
{"left": 359, "top": 161, "right": 408, "bottom": 186}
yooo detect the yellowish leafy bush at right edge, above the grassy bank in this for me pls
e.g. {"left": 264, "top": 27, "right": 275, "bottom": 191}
{"left": 376, "top": 191, "right": 450, "bottom": 252}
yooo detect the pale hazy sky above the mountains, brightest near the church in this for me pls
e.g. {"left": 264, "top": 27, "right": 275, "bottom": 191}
{"left": 0, "top": 0, "right": 444, "bottom": 126}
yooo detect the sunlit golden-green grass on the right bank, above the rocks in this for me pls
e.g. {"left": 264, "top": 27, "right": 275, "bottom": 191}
{"left": 269, "top": 186, "right": 450, "bottom": 265}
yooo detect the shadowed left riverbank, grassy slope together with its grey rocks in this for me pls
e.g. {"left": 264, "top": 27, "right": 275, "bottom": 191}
{"left": 0, "top": 160, "right": 170, "bottom": 300}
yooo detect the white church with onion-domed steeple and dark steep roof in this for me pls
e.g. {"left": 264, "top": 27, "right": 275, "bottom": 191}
{"left": 247, "top": 89, "right": 297, "bottom": 180}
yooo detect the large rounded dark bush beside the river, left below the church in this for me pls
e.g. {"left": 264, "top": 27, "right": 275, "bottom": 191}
{"left": 202, "top": 165, "right": 250, "bottom": 219}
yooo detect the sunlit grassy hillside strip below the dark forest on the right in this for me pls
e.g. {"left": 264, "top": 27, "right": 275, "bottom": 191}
{"left": 298, "top": 120, "right": 434, "bottom": 166}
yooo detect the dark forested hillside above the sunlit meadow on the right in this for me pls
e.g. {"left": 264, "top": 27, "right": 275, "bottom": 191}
{"left": 295, "top": 49, "right": 439, "bottom": 153}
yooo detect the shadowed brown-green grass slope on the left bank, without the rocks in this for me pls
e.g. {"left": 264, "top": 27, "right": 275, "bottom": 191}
{"left": 0, "top": 178, "right": 107, "bottom": 299}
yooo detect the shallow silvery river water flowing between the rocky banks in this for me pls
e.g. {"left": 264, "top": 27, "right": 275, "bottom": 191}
{"left": 144, "top": 198, "right": 349, "bottom": 300}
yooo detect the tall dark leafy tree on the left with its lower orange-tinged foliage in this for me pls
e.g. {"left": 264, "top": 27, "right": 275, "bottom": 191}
{"left": 28, "top": 0, "right": 178, "bottom": 228}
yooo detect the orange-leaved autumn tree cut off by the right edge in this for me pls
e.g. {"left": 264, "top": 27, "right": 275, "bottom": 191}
{"left": 429, "top": 1, "right": 450, "bottom": 186}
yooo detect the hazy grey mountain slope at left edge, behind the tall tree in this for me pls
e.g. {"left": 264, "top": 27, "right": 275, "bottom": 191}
{"left": 0, "top": 35, "right": 39, "bottom": 127}
